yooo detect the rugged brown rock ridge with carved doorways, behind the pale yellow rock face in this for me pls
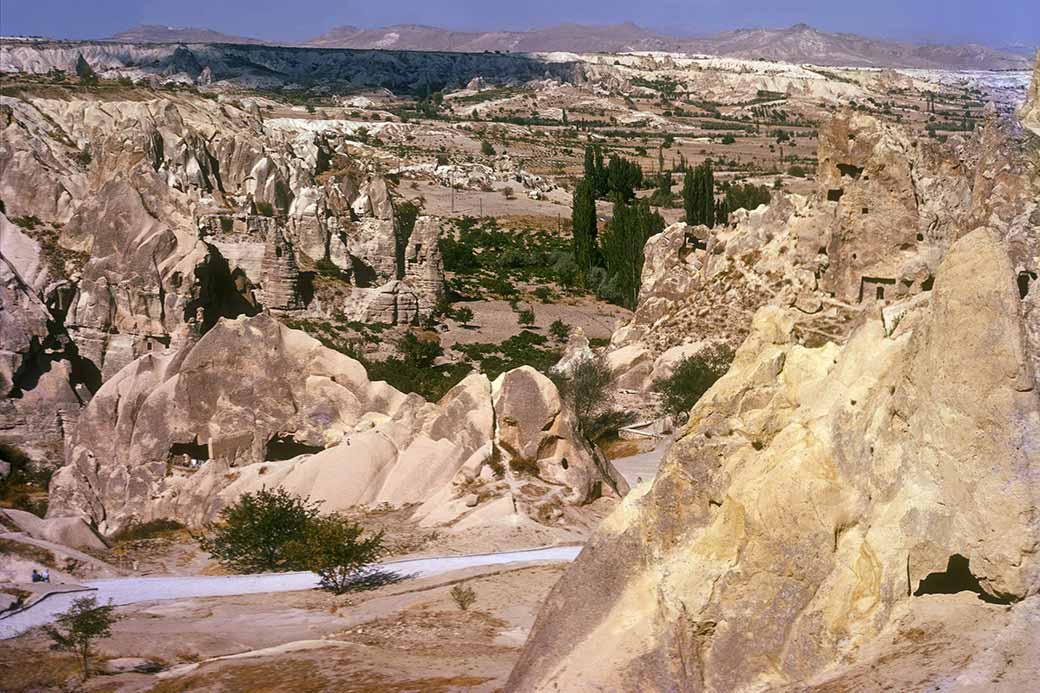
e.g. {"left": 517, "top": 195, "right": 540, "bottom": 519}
{"left": 610, "top": 113, "right": 1040, "bottom": 386}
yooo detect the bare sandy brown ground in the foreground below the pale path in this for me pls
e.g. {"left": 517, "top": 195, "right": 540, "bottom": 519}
{"left": 0, "top": 565, "right": 563, "bottom": 692}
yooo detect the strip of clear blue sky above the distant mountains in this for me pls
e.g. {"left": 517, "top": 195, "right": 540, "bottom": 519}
{"left": 0, "top": 0, "right": 1040, "bottom": 46}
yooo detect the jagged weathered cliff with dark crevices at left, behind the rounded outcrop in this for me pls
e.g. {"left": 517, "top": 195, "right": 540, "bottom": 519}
{"left": 0, "top": 89, "right": 451, "bottom": 466}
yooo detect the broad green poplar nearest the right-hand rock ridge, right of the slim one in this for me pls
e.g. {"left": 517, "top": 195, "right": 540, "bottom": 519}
{"left": 601, "top": 197, "right": 665, "bottom": 309}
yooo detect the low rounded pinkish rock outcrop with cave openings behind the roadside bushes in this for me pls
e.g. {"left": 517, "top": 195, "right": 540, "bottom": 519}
{"left": 48, "top": 313, "right": 624, "bottom": 533}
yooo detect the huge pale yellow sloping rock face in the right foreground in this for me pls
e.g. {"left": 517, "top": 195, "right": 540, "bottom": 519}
{"left": 510, "top": 228, "right": 1040, "bottom": 691}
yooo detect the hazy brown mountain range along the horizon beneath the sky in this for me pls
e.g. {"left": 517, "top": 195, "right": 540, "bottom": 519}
{"left": 103, "top": 22, "right": 1032, "bottom": 70}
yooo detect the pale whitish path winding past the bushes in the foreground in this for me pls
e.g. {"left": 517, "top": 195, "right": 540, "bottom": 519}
{"left": 0, "top": 546, "right": 581, "bottom": 640}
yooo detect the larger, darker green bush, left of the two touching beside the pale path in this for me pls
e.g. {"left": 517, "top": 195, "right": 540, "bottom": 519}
{"left": 199, "top": 488, "right": 318, "bottom": 572}
